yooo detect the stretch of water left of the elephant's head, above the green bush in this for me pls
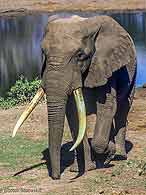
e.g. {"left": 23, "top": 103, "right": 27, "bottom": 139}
{"left": 0, "top": 15, "right": 48, "bottom": 95}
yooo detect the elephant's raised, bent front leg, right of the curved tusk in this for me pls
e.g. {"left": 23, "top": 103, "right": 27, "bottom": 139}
{"left": 91, "top": 84, "right": 117, "bottom": 158}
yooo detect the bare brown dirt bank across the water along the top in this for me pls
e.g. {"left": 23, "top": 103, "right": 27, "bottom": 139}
{"left": 0, "top": 0, "right": 146, "bottom": 16}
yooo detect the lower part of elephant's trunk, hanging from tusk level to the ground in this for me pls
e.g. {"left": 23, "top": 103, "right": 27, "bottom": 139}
{"left": 48, "top": 100, "right": 66, "bottom": 179}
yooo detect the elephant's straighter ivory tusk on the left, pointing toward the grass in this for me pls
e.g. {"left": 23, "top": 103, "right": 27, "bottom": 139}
{"left": 12, "top": 88, "right": 44, "bottom": 137}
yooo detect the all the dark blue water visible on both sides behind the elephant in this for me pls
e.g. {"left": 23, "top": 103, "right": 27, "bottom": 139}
{"left": 0, "top": 12, "right": 146, "bottom": 95}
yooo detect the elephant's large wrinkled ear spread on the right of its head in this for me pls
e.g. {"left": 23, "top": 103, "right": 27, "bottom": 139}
{"left": 84, "top": 18, "right": 133, "bottom": 88}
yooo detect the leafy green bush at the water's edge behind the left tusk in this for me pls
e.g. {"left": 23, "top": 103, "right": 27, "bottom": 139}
{"left": 0, "top": 76, "right": 41, "bottom": 109}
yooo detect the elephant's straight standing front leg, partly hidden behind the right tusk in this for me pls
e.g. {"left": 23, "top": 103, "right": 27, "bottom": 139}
{"left": 66, "top": 96, "right": 96, "bottom": 172}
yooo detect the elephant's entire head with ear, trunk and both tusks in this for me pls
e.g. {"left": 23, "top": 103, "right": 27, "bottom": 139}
{"left": 13, "top": 16, "right": 134, "bottom": 178}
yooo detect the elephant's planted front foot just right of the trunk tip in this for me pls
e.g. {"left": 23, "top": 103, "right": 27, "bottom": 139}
{"left": 70, "top": 160, "right": 96, "bottom": 172}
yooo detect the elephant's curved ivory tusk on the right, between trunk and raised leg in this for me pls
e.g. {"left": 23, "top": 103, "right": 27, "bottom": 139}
{"left": 70, "top": 88, "right": 86, "bottom": 151}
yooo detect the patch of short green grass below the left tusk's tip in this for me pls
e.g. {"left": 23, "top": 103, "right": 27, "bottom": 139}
{"left": 0, "top": 135, "right": 47, "bottom": 170}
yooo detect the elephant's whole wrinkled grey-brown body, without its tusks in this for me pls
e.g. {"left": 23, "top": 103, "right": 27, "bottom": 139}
{"left": 42, "top": 16, "right": 136, "bottom": 179}
